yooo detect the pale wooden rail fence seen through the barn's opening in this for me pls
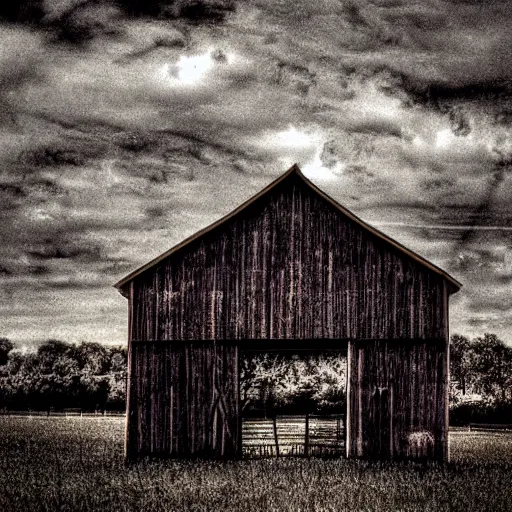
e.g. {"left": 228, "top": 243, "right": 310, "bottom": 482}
{"left": 242, "top": 415, "right": 345, "bottom": 458}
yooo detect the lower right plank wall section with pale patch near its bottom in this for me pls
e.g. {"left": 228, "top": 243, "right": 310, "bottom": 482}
{"left": 347, "top": 340, "right": 448, "bottom": 460}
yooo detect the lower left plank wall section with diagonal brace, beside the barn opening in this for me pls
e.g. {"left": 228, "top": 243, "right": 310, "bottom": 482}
{"left": 126, "top": 342, "right": 241, "bottom": 459}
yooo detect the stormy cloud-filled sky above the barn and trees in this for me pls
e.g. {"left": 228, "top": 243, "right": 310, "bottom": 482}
{"left": 0, "top": 0, "right": 512, "bottom": 345}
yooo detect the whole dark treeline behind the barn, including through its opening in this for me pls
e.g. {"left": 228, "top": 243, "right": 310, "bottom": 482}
{"left": 0, "top": 333, "right": 512, "bottom": 425}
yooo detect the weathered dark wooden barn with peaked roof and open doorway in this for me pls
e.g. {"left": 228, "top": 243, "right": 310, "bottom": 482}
{"left": 116, "top": 165, "right": 460, "bottom": 460}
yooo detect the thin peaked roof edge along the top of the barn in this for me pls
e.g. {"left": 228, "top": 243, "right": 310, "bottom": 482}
{"left": 114, "top": 164, "right": 462, "bottom": 297}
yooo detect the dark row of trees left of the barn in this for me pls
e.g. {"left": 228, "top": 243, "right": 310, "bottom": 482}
{"left": 0, "top": 338, "right": 127, "bottom": 411}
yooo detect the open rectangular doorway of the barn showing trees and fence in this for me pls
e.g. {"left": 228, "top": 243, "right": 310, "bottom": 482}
{"left": 240, "top": 350, "right": 347, "bottom": 458}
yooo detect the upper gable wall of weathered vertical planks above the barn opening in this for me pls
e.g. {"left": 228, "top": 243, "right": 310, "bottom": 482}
{"left": 131, "top": 175, "right": 445, "bottom": 340}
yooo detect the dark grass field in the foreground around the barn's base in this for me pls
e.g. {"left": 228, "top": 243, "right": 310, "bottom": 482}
{"left": 0, "top": 417, "right": 512, "bottom": 512}
